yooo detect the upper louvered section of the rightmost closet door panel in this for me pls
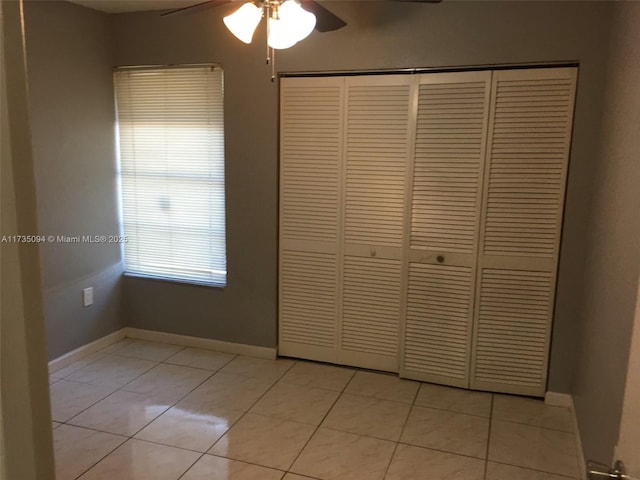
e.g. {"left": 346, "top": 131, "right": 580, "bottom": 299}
{"left": 483, "top": 73, "right": 574, "bottom": 258}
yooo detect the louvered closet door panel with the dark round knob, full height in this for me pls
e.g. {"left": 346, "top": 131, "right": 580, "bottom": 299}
{"left": 400, "top": 72, "right": 491, "bottom": 387}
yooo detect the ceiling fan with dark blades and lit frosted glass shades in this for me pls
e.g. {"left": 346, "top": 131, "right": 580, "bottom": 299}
{"left": 161, "top": 0, "right": 442, "bottom": 82}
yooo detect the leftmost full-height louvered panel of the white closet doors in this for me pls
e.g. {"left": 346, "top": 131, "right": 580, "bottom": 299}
{"left": 279, "top": 78, "right": 344, "bottom": 362}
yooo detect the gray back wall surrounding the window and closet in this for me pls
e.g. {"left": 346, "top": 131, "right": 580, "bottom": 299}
{"left": 114, "top": 1, "right": 612, "bottom": 392}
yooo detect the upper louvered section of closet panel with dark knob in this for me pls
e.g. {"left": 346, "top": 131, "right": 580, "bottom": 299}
{"left": 411, "top": 72, "right": 489, "bottom": 254}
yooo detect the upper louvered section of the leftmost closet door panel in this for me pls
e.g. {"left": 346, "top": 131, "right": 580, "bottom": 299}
{"left": 280, "top": 78, "right": 342, "bottom": 242}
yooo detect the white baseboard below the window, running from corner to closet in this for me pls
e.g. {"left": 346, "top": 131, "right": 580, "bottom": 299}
{"left": 124, "top": 327, "right": 277, "bottom": 360}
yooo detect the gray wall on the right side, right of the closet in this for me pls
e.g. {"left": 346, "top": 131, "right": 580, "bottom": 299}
{"left": 574, "top": 2, "right": 640, "bottom": 461}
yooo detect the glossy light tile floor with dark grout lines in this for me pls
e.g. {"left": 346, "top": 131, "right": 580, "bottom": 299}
{"left": 50, "top": 339, "right": 579, "bottom": 480}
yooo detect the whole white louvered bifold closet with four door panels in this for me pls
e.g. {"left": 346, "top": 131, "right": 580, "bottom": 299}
{"left": 279, "top": 68, "right": 577, "bottom": 395}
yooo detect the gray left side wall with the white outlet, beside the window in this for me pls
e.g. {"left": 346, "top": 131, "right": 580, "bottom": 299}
{"left": 25, "top": 1, "right": 124, "bottom": 358}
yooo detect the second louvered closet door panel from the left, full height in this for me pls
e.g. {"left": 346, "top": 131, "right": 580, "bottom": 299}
{"left": 339, "top": 75, "right": 412, "bottom": 372}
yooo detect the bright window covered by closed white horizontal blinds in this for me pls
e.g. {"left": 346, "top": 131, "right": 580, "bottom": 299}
{"left": 115, "top": 66, "right": 227, "bottom": 286}
